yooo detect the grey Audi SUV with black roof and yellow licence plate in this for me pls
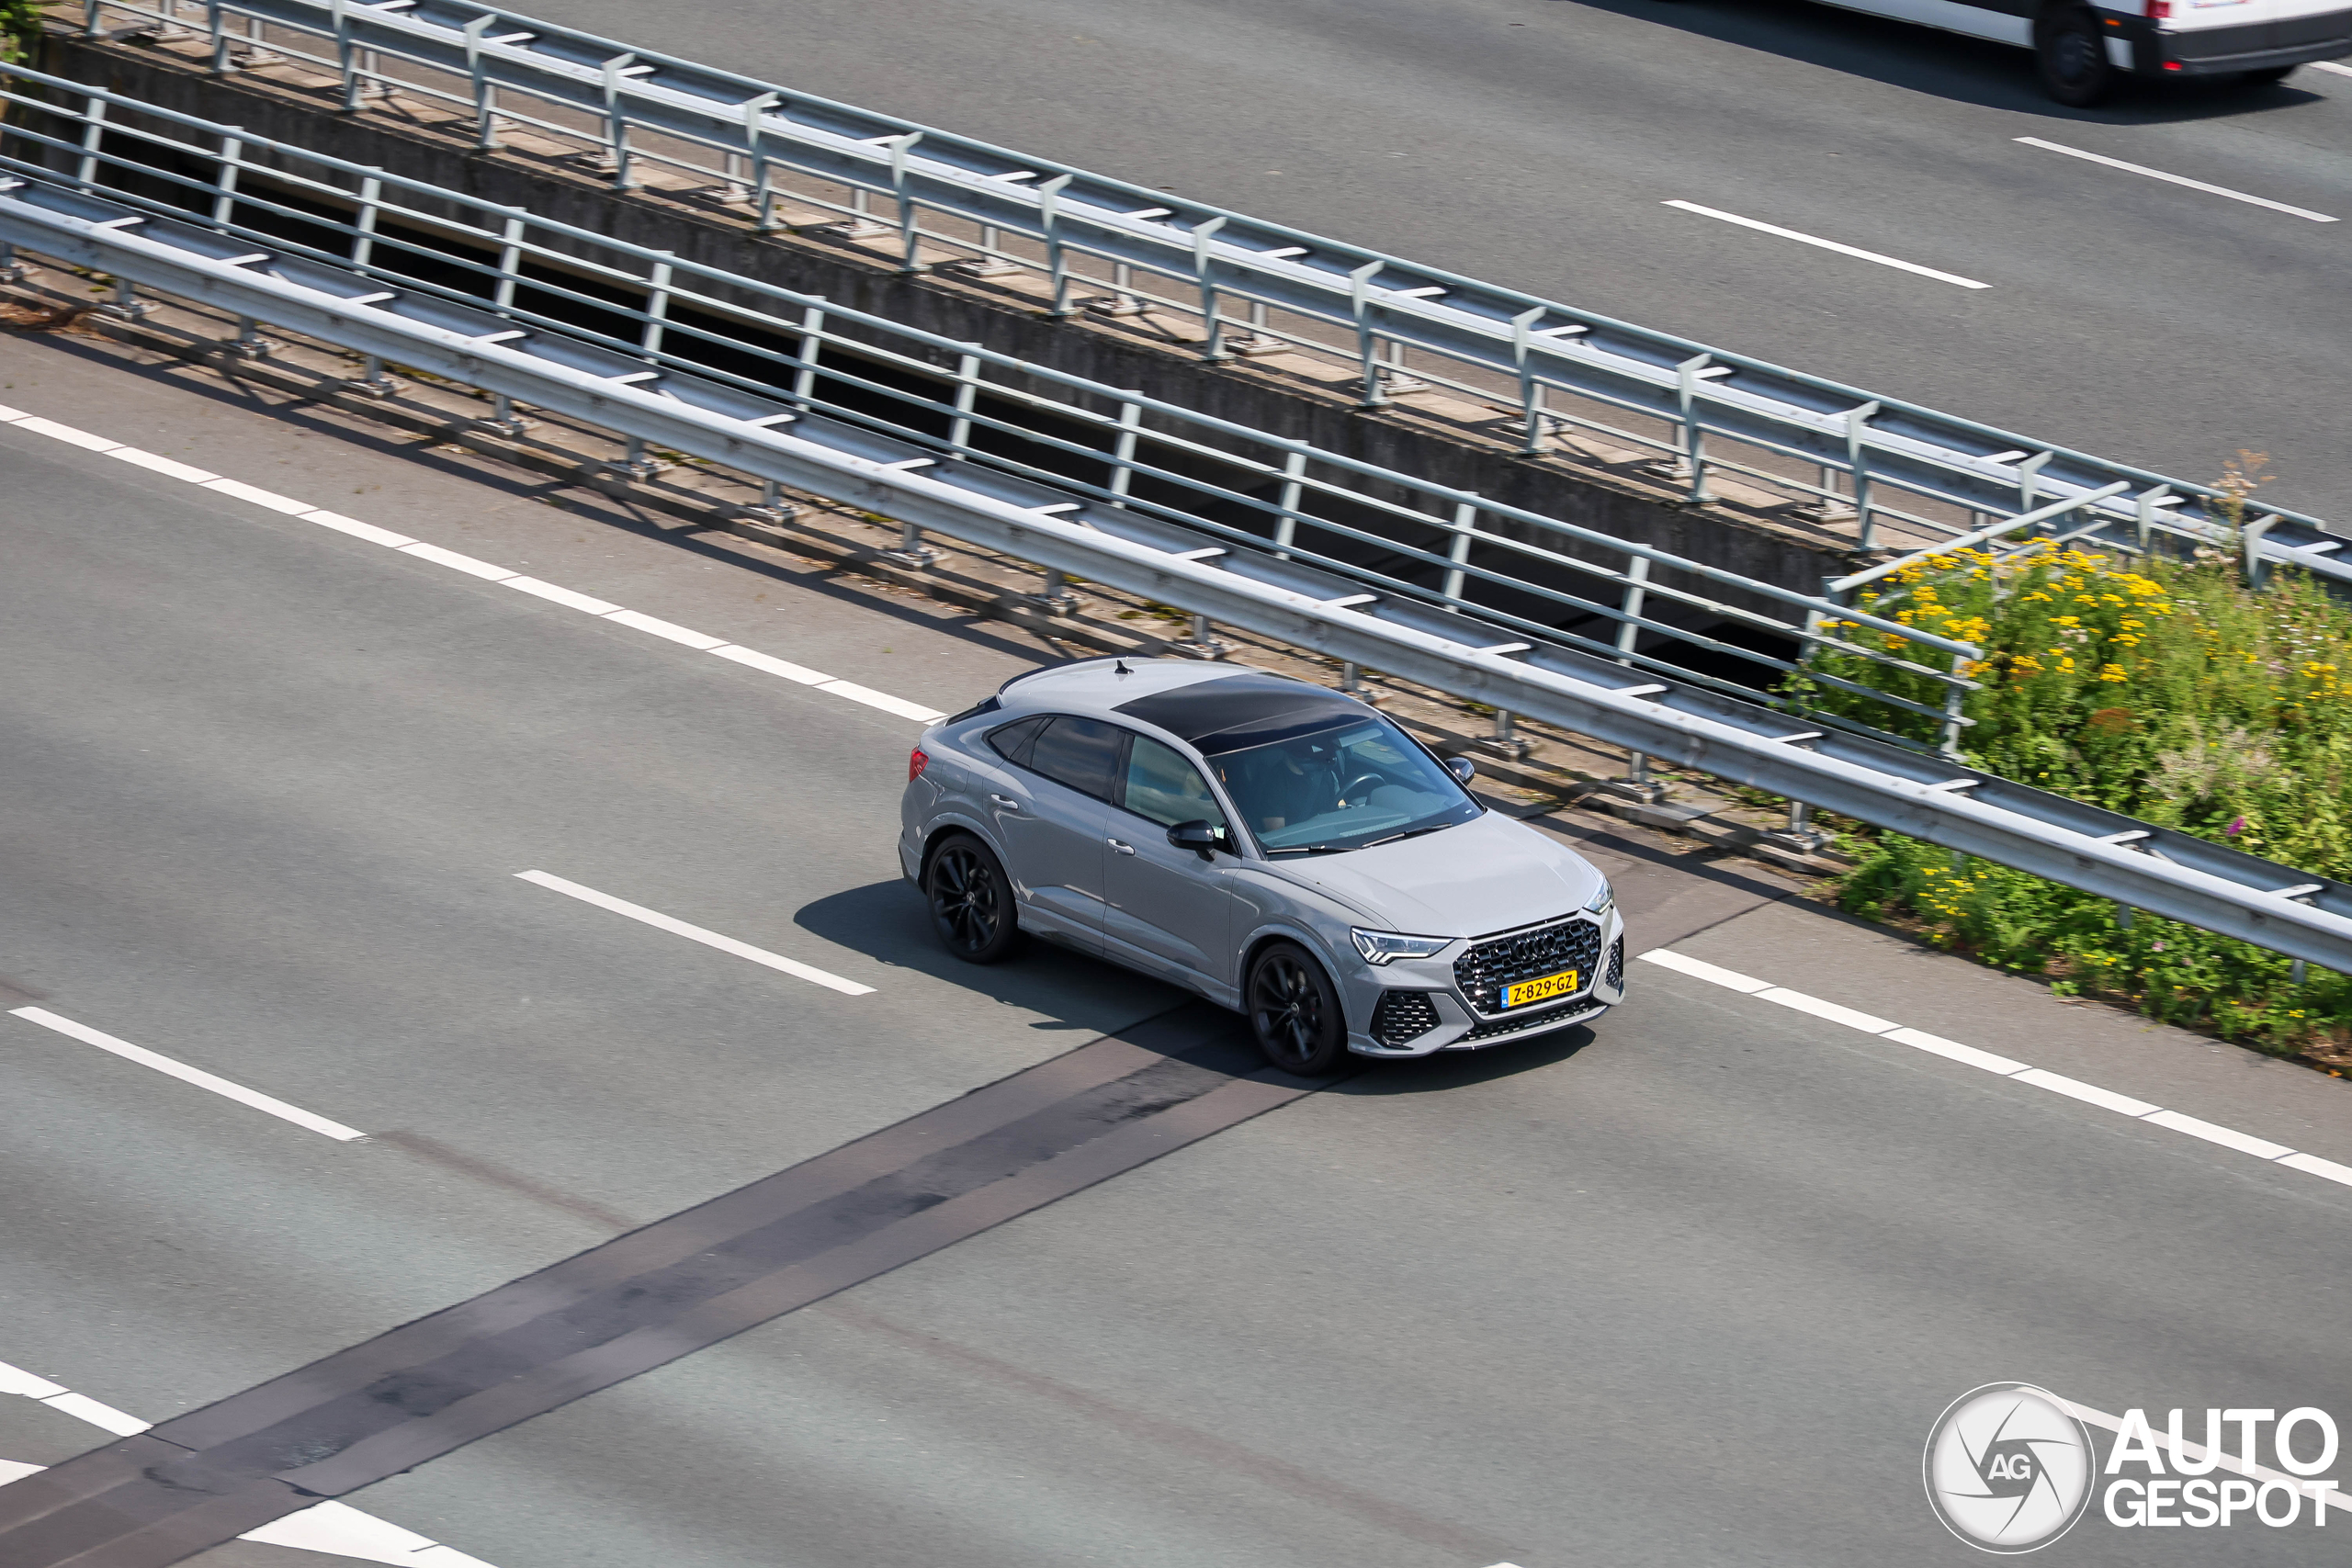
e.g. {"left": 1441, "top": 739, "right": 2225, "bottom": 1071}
{"left": 899, "top": 659, "right": 1625, "bottom": 1075}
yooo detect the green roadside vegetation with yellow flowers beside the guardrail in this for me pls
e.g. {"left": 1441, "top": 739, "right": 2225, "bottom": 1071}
{"left": 1806, "top": 454, "right": 2352, "bottom": 1063}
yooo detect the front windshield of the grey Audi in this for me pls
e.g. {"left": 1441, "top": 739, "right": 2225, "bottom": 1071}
{"left": 1209, "top": 715, "right": 1482, "bottom": 856}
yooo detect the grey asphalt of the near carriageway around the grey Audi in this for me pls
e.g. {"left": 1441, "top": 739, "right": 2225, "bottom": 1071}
{"left": 0, "top": 339, "right": 2352, "bottom": 1568}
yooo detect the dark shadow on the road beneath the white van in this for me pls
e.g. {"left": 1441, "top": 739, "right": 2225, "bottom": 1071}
{"left": 1553, "top": 0, "right": 2326, "bottom": 125}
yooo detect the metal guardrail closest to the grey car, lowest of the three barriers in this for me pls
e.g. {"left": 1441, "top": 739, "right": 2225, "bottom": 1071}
{"left": 0, "top": 165, "right": 2352, "bottom": 971}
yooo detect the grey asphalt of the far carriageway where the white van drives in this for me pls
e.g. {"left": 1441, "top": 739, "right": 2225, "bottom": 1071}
{"left": 514, "top": 0, "right": 2352, "bottom": 525}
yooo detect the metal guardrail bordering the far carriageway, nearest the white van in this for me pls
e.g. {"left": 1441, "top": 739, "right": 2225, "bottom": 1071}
{"left": 64, "top": 0, "right": 2352, "bottom": 592}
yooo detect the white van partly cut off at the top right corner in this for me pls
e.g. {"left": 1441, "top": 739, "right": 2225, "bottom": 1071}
{"left": 1796, "top": 0, "right": 2352, "bottom": 108}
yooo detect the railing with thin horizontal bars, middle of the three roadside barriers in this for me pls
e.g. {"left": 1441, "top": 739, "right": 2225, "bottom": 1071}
{"left": 0, "top": 66, "right": 2004, "bottom": 750}
